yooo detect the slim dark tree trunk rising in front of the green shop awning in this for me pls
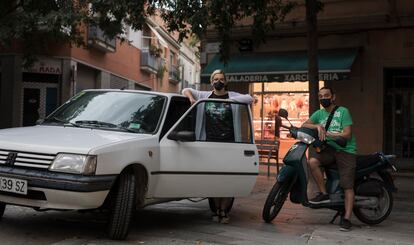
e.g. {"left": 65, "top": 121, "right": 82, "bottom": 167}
{"left": 306, "top": 0, "right": 319, "bottom": 115}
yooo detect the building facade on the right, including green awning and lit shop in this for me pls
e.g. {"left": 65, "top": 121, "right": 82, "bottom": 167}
{"left": 201, "top": 0, "right": 414, "bottom": 159}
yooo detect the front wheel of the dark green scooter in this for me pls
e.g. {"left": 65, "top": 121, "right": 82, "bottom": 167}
{"left": 262, "top": 181, "right": 289, "bottom": 223}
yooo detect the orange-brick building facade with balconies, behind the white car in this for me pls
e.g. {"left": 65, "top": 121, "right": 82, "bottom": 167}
{"left": 0, "top": 17, "right": 199, "bottom": 128}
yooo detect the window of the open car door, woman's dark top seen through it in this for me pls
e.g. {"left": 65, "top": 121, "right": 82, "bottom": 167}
{"left": 174, "top": 100, "right": 252, "bottom": 143}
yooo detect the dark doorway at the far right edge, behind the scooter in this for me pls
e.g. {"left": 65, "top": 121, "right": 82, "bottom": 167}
{"left": 384, "top": 68, "right": 414, "bottom": 160}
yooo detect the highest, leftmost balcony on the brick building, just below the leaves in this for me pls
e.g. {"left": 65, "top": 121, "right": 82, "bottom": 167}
{"left": 88, "top": 25, "right": 116, "bottom": 53}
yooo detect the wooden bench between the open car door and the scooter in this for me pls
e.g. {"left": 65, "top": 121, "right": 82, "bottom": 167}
{"left": 255, "top": 140, "right": 279, "bottom": 176}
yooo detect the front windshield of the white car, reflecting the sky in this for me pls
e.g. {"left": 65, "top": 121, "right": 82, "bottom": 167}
{"left": 43, "top": 91, "right": 166, "bottom": 134}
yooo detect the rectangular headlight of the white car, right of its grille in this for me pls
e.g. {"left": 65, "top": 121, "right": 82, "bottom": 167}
{"left": 49, "top": 153, "right": 96, "bottom": 175}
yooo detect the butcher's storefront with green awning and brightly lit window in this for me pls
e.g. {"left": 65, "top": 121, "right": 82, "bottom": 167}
{"left": 201, "top": 49, "right": 357, "bottom": 156}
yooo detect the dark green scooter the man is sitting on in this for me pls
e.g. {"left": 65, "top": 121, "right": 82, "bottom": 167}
{"left": 262, "top": 109, "right": 397, "bottom": 225}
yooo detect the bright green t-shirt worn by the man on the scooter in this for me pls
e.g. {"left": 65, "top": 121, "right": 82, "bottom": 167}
{"left": 309, "top": 106, "right": 357, "bottom": 154}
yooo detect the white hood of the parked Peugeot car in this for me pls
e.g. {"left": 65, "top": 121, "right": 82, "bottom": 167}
{"left": 0, "top": 125, "right": 150, "bottom": 154}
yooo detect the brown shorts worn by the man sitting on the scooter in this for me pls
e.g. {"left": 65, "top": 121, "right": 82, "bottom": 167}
{"left": 313, "top": 147, "right": 356, "bottom": 189}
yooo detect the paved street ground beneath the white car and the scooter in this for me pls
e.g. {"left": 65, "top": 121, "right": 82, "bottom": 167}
{"left": 0, "top": 173, "right": 414, "bottom": 245}
